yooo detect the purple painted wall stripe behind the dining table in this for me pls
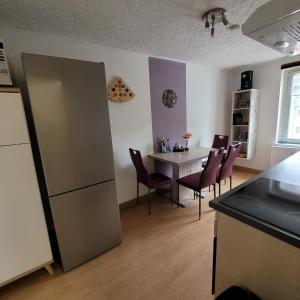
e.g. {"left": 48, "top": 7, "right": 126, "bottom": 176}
{"left": 149, "top": 57, "right": 187, "bottom": 175}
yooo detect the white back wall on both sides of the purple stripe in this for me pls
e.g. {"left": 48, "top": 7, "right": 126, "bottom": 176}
{"left": 0, "top": 27, "right": 230, "bottom": 203}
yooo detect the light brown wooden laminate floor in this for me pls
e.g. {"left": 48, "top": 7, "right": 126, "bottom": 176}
{"left": 0, "top": 171, "right": 255, "bottom": 300}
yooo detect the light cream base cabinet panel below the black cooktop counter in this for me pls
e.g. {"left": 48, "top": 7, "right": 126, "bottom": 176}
{"left": 214, "top": 212, "right": 300, "bottom": 300}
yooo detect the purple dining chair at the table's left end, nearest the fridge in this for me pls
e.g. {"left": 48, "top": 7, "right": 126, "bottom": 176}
{"left": 129, "top": 148, "right": 173, "bottom": 215}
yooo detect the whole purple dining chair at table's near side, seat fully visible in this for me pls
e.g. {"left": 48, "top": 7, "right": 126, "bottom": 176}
{"left": 177, "top": 148, "right": 224, "bottom": 220}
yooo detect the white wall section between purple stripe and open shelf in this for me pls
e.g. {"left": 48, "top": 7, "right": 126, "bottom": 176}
{"left": 186, "top": 64, "right": 231, "bottom": 147}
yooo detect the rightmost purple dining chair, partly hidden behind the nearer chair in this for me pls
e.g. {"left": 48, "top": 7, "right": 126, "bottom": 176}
{"left": 217, "top": 143, "right": 241, "bottom": 196}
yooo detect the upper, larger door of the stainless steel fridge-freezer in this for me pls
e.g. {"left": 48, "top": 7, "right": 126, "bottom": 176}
{"left": 22, "top": 54, "right": 115, "bottom": 196}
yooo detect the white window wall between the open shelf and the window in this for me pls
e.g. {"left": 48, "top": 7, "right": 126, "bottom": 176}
{"left": 228, "top": 56, "right": 300, "bottom": 170}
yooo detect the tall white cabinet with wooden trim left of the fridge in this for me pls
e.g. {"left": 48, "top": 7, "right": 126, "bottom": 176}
{"left": 0, "top": 89, "right": 53, "bottom": 286}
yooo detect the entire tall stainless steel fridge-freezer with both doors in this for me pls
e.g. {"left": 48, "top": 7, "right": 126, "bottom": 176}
{"left": 22, "top": 54, "right": 121, "bottom": 271}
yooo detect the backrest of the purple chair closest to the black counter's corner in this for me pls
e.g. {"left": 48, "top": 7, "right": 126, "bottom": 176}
{"left": 199, "top": 148, "right": 225, "bottom": 188}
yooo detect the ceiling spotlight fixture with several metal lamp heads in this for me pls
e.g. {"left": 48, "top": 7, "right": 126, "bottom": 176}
{"left": 202, "top": 7, "right": 240, "bottom": 37}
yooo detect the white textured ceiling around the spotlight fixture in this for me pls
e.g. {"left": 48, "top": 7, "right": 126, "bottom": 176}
{"left": 0, "top": 0, "right": 281, "bottom": 67}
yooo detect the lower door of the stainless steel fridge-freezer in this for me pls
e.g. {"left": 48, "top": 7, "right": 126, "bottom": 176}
{"left": 50, "top": 180, "right": 121, "bottom": 271}
